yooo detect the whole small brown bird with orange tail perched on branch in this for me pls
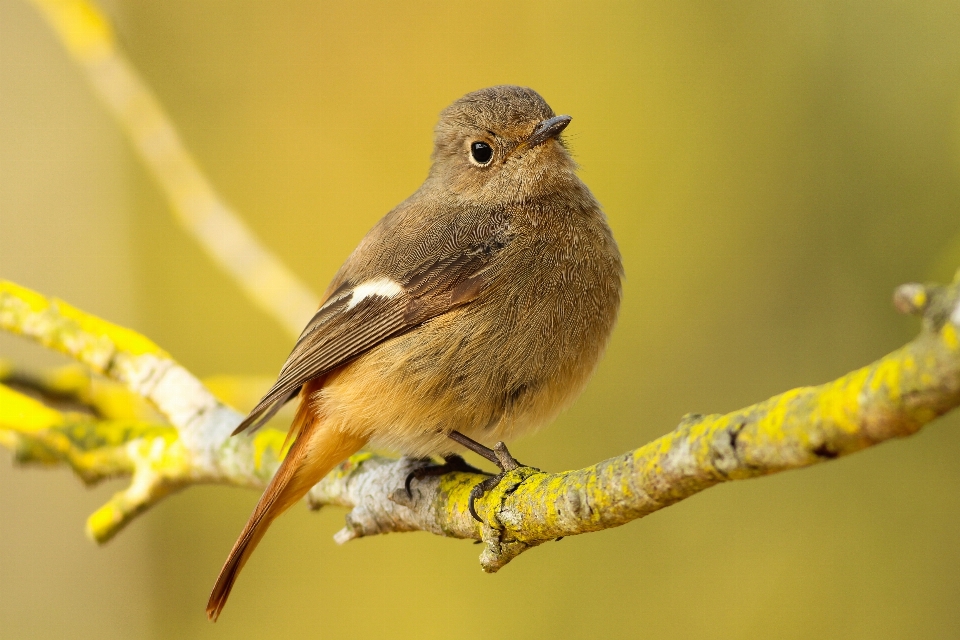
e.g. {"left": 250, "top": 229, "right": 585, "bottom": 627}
{"left": 207, "top": 86, "right": 623, "bottom": 620}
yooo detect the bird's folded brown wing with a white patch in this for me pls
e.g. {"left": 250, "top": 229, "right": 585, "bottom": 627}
{"left": 233, "top": 241, "right": 505, "bottom": 434}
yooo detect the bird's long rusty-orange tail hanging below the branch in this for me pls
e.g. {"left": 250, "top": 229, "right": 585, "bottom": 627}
{"left": 207, "top": 398, "right": 366, "bottom": 621}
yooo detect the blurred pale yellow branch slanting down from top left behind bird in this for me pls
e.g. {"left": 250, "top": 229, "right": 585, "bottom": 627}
{"left": 32, "top": 0, "right": 320, "bottom": 338}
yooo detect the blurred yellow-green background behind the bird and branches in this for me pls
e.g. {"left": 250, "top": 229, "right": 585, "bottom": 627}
{"left": 0, "top": 0, "right": 960, "bottom": 639}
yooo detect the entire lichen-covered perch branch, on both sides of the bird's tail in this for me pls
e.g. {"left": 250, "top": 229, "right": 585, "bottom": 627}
{"left": 0, "top": 273, "right": 960, "bottom": 572}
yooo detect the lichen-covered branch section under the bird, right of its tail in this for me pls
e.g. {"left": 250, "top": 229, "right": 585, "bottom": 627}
{"left": 311, "top": 274, "right": 960, "bottom": 571}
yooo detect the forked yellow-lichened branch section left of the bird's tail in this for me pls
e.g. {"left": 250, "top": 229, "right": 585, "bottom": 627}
{"left": 0, "top": 281, "right": 283, "bottom": 541}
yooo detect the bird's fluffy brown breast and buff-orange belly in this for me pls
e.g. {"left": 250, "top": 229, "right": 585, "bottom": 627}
{"left": 318, "top": 199, "right": 621, "bottom": 455}
